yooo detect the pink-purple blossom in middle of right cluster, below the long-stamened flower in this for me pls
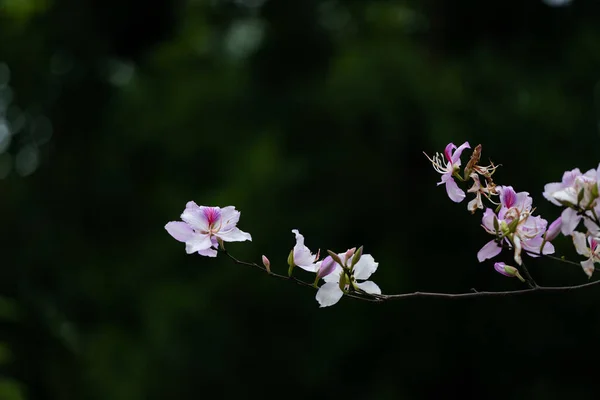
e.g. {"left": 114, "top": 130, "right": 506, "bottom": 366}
{"left": 477, "top": 186, "right": 554, "bottom": 265}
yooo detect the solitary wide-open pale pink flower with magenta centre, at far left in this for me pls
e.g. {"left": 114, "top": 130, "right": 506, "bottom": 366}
{"left": 165, "top": 201, "right": 252, "bottom": 257}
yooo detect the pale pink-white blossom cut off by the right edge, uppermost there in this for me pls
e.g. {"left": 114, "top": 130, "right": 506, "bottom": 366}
{"left": 543, "top": 165, "right": 600, "bottom": 235}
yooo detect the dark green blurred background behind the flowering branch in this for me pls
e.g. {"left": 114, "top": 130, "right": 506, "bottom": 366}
{"left": 0, "top": 0, "right": 600, "bottom": 400}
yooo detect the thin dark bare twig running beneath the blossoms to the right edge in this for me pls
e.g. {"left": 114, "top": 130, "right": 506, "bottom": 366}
{"left": 219, "top": 249, "right": 600, "bottom": 303}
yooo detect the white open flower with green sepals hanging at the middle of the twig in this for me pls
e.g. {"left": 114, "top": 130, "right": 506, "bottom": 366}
{"left": 316, "top": 248, "right": 381, "bottom": 307}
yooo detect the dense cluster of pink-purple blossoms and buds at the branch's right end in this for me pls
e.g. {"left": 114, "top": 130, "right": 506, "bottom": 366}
{"left": 426, "top": 142, "right": 600, "bottom": 280}
